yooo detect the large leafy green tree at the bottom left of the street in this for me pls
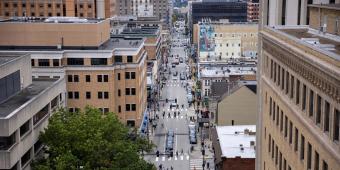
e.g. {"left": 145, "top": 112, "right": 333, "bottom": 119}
{"left": 32, "top": 107, "right": 155, "bottom": 170}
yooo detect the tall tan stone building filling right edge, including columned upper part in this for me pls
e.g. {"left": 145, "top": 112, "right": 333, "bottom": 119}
{"left": 256, "top": 0, "right": 340, "bottom": 170}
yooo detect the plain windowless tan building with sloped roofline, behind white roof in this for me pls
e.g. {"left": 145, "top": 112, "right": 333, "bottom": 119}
{"left": 216, "top": 85, "right": 257, "bottom": 126}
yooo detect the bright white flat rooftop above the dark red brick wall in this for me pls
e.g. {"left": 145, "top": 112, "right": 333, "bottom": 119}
{"left": 216, "top": 125, "right": 256, "bottom": 158}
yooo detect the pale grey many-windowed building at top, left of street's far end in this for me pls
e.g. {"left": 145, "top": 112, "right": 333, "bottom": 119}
{"left": 116, "top": 0, "right": 169, "bottom": 20}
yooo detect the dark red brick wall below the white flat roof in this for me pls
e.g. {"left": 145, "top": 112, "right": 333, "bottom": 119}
{"left": 222, "top": 157, "right": 255, "bottom": 170}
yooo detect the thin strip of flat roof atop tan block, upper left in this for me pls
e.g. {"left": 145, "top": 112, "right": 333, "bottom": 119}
{"left": 0, "top": 17, "right": 103, "bottom": 24}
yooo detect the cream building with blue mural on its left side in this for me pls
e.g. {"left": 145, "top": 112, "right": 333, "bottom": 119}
{"left": 194, "top": 21, "right": 258, "bottom": 62}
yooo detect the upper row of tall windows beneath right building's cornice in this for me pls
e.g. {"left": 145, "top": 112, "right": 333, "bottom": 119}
{"left": 266, "top": 56, "right": 340, "bottom": 143}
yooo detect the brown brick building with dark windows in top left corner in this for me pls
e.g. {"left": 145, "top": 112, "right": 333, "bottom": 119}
{"left": 0, "top": 0, "right": 117, "bottom": 18}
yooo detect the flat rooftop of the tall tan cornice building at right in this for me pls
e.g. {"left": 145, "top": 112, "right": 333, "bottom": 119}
{"left": 275, "top": 26, "right": 340, "bottom": 61}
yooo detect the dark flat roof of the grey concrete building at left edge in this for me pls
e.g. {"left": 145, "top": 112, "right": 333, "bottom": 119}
{"left": 0, "top": 79, "right": 59, "bottom": 118}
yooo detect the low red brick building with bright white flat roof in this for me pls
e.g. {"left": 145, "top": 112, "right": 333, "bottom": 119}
{"left": 212, "top": 125, "right": 256, "bottom": 170}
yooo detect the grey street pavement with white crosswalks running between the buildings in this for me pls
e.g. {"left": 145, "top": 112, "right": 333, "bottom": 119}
{"left": 144, "top": 28, "right": 214, "bottom": 170}
